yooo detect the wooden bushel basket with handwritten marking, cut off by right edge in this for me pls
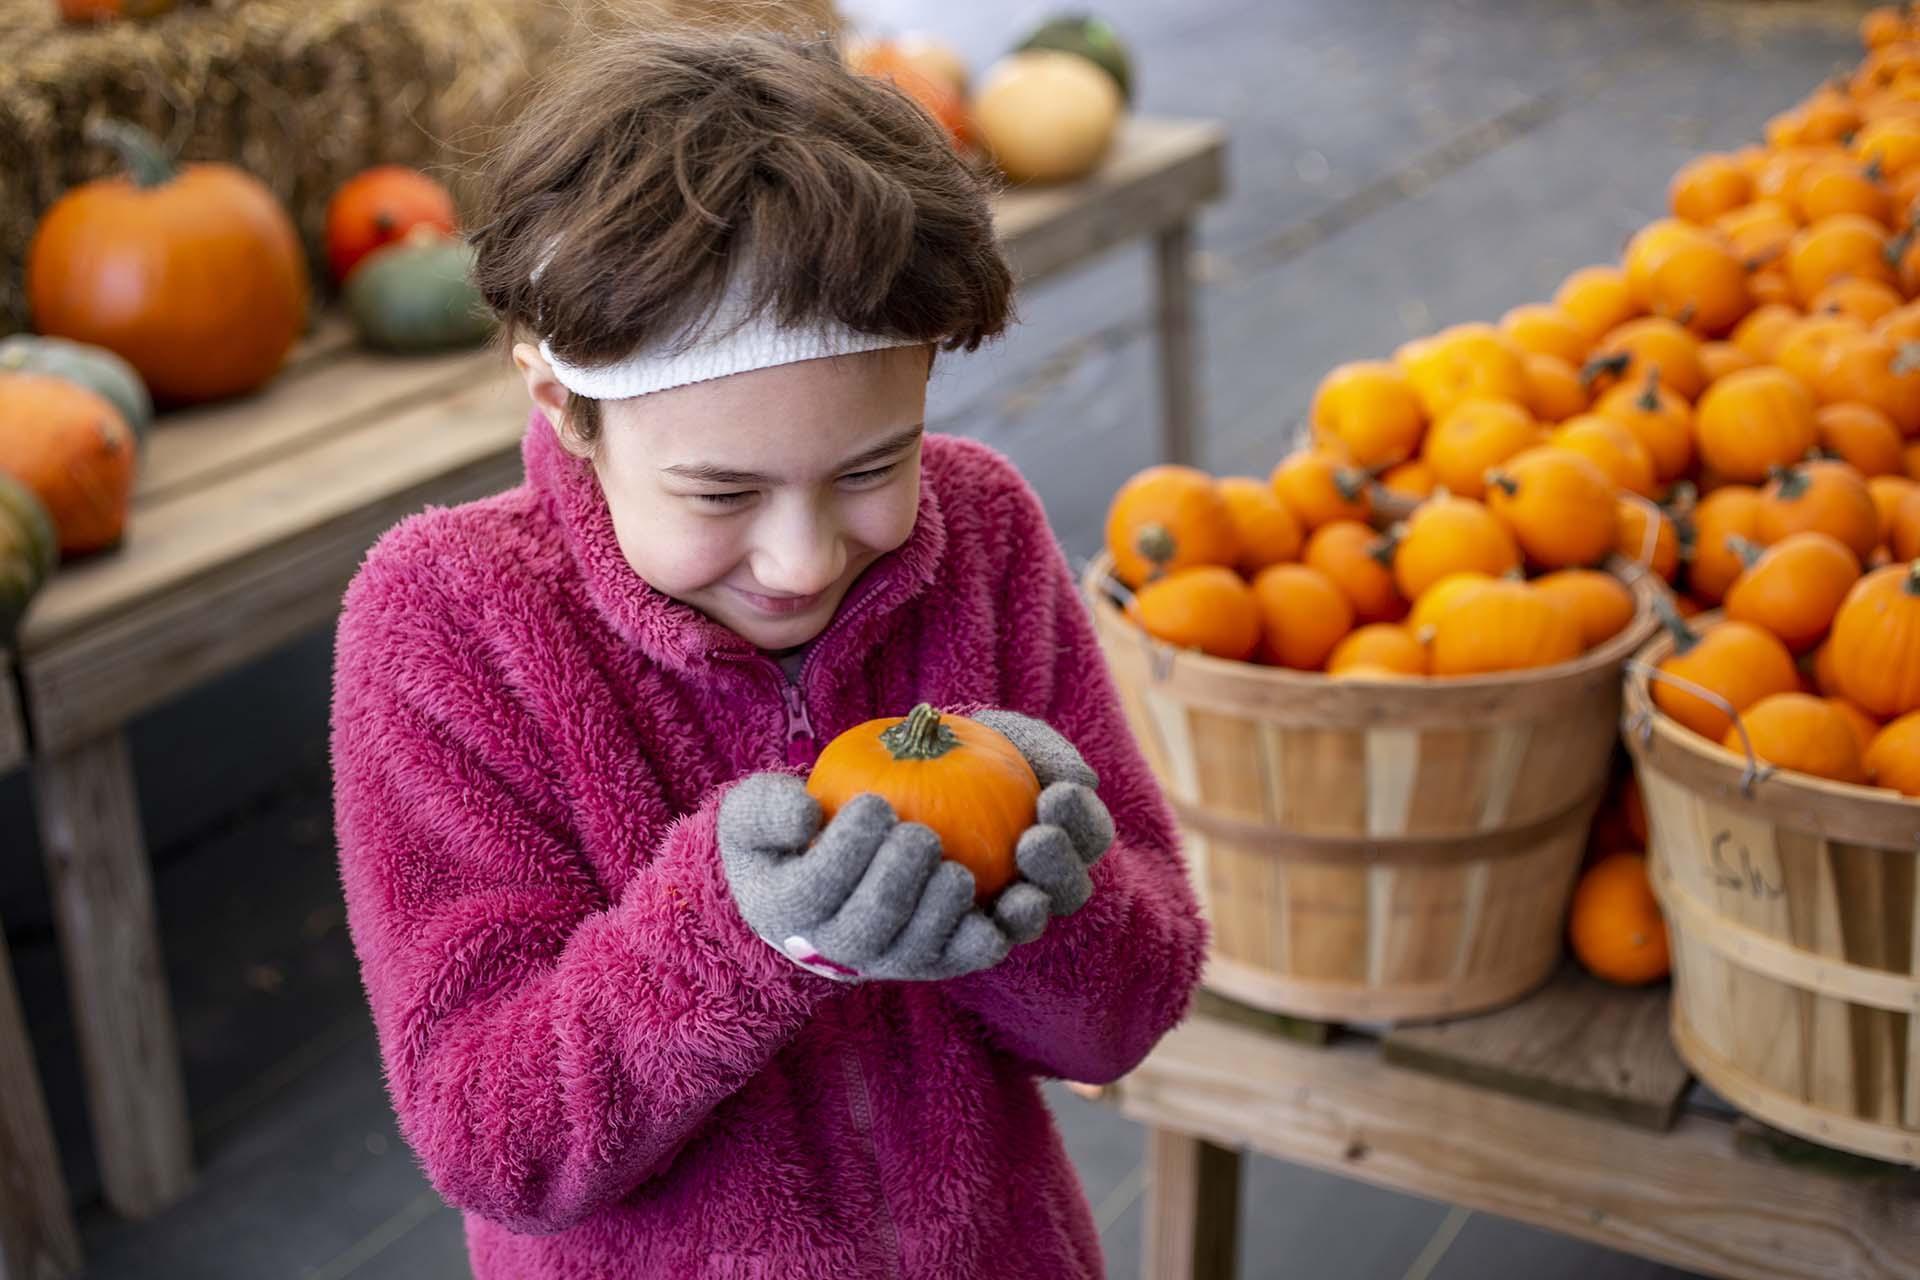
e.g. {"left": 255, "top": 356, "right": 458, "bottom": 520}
{"left": 1624, "top": 618, "right": 1920, "bottom": 1165}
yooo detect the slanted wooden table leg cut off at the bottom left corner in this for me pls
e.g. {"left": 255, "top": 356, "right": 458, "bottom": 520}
{"left": 0, "top": 917, "right": 81, "bottom": 1280}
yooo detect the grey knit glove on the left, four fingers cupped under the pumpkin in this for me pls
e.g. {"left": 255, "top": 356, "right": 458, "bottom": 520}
{"left": 720, "top": 773, "right": 1012, "bottom": 983}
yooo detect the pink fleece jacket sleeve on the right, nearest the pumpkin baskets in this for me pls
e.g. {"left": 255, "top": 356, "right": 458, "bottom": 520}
{"left": 948, "top": 466, "right": 1208, "bottom": 1084}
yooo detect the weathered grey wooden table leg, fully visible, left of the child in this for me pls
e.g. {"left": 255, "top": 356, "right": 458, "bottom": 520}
{"left": 33, "top": 731, "right": 194, "bottom": 1217}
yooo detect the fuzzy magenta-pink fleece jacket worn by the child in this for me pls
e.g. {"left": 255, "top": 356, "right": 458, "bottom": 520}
{"left": 332, "top": 415, "right": 1204, "bottom": 1280}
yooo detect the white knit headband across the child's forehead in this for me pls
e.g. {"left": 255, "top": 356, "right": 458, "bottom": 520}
{"left": 534, "top": 263, "right": 922, "bottom": 399}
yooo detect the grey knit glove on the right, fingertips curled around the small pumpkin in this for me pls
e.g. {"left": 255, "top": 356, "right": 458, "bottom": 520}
{"left": 968, "top": 710, "right": 1114, "bottom": 944}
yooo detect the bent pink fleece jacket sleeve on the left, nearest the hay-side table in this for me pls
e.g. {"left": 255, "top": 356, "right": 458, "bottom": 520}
{"left": 332, "top": 545, "right": 833, "bottom": 1234}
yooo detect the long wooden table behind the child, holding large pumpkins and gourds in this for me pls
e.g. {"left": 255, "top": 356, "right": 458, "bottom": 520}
{"left": 0, "top": 121, "right": 1225, "bottom": 1235}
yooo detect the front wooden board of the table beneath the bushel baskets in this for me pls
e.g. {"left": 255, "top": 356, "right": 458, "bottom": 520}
{"left": 1110, "top": 1015, "right": 1920, "bottom": 1280}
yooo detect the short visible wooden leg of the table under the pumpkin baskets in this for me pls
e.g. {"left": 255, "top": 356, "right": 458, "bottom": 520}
{"left": 1144, "top": 1128, "right": 1240, "bottom": 1280}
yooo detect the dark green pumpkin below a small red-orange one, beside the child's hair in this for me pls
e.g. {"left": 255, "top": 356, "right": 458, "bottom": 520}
{"left": 346, "top": 228, "right": 493, "bottom": 353}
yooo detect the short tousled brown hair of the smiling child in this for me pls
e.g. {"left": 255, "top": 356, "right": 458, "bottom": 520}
{"left": 470, "top": 33, "right": 1012, "bottom": 441}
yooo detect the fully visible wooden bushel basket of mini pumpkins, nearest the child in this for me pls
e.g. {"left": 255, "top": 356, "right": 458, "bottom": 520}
{"left": 1083, "top": 557, "right": 1655, "bottom": 1021}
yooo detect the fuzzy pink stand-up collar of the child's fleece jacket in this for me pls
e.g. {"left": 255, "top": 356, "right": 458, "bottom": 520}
{"left": 520, "top": 409, "right": 947, "bottom": 672}
